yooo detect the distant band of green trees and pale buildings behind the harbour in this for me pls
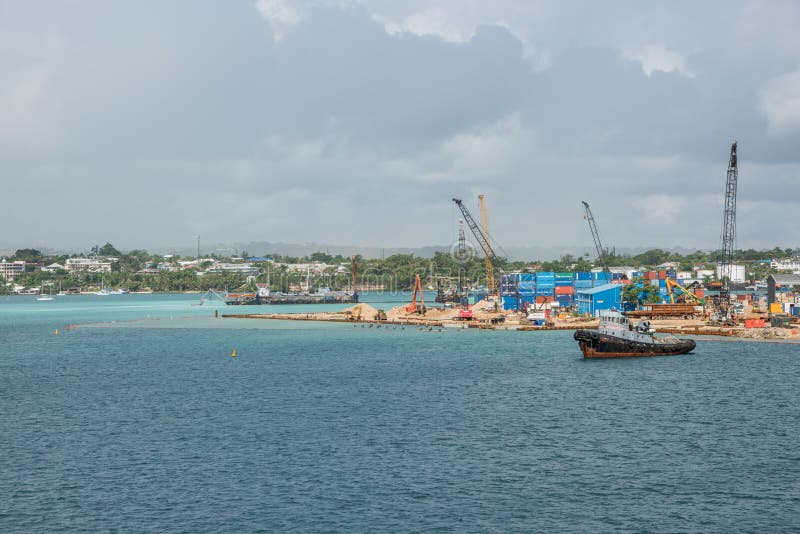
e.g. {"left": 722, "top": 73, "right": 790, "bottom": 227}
{"left": 0, "top": 243, "right": 800, "bottom": 294}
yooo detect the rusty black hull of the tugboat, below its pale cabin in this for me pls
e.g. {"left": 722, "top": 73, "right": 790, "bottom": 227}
{"left": 573, "top": 330, "right": 697, "bottom": 359}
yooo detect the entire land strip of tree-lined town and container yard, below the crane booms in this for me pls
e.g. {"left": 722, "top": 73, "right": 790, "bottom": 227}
{"left": 0, "top": 243, "right": 800, "bottom": 338}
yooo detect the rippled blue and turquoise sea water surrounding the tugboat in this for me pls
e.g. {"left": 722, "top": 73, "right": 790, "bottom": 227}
{"left": 0, "top": 295, "right": 800, "bottom": 532}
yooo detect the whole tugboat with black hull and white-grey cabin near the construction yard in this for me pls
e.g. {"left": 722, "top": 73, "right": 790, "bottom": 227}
{"left": 574, "top": 310, "right": 696, "bottom": 359}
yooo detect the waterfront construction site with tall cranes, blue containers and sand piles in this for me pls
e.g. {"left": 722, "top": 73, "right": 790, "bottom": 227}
{"left": 223, "top": 141, "right": 800, "bottom": 340}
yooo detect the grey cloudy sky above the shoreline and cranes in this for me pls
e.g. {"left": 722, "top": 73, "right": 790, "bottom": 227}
{"left": 0, "top": 0, "right": 800, "bottom": 253}
